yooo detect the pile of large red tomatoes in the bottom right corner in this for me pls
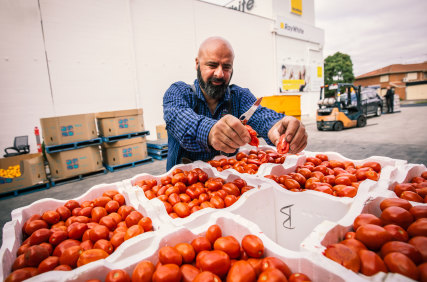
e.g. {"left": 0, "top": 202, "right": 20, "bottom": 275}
{"left": 324, "top": 198, "right": 427, "bottom": 281}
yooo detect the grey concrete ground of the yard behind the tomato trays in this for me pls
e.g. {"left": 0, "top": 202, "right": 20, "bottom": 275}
{"left": 0, "top": 104, "right": 427, "bottom": 247}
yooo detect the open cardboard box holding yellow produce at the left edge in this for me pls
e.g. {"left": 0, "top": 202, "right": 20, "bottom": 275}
{"left": 0, "top": 153, "right": 47, "bottom": 193}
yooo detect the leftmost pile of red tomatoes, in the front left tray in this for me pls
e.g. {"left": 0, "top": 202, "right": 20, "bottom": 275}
{"left": 6, "top": 190, "right": 153, "bottom": 281}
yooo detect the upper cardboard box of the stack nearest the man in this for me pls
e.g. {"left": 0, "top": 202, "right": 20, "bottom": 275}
{"left": 96, "top": 109, "right": 144, "bottom": 137}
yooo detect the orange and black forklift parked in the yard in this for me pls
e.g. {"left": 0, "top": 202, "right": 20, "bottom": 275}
{"left": 316, "top": 83, "right": 366, "bottom": 131}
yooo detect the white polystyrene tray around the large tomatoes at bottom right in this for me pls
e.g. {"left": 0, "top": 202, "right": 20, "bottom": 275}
{"left": 301, "top": 194, "right": 423, "bottom": 281}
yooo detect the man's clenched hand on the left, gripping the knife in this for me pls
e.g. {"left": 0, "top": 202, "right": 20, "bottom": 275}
{"left": 208, "top": 115, "right": 251, "bottom": 153}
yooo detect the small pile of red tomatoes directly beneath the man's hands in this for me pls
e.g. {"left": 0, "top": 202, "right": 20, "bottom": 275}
{"left": 208, "top": 149, "right": 286, "bottom": 174}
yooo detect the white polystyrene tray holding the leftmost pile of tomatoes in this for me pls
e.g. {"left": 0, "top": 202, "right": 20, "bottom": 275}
{"left": 0, "top": 182, "right": 159, "bottom": 280}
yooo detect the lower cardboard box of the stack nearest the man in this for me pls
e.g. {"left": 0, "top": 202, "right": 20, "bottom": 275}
{"left": 102, "top": 137, "right": 147, "bottom": 166}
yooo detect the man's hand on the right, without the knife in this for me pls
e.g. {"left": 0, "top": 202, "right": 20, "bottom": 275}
{"left": 268, "top": 116, "right": 307, "bottom": 154}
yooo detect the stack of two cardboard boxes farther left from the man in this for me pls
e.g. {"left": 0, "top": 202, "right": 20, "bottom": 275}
{"left": 40, "top": 114, "right": 103, "bottom": 180}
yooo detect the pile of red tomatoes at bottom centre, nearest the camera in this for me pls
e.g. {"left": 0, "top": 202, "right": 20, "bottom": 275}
{"left": 83, "top": 224, "right": 311, "bottom": 282}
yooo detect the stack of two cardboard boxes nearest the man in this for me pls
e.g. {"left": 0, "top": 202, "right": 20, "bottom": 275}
{"left": 96, "top": 109, "right": 147, "bottom": 167}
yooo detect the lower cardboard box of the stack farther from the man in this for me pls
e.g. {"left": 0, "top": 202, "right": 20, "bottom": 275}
{"left": 46, "top": 146, "right": 102, "bottom": 179}
